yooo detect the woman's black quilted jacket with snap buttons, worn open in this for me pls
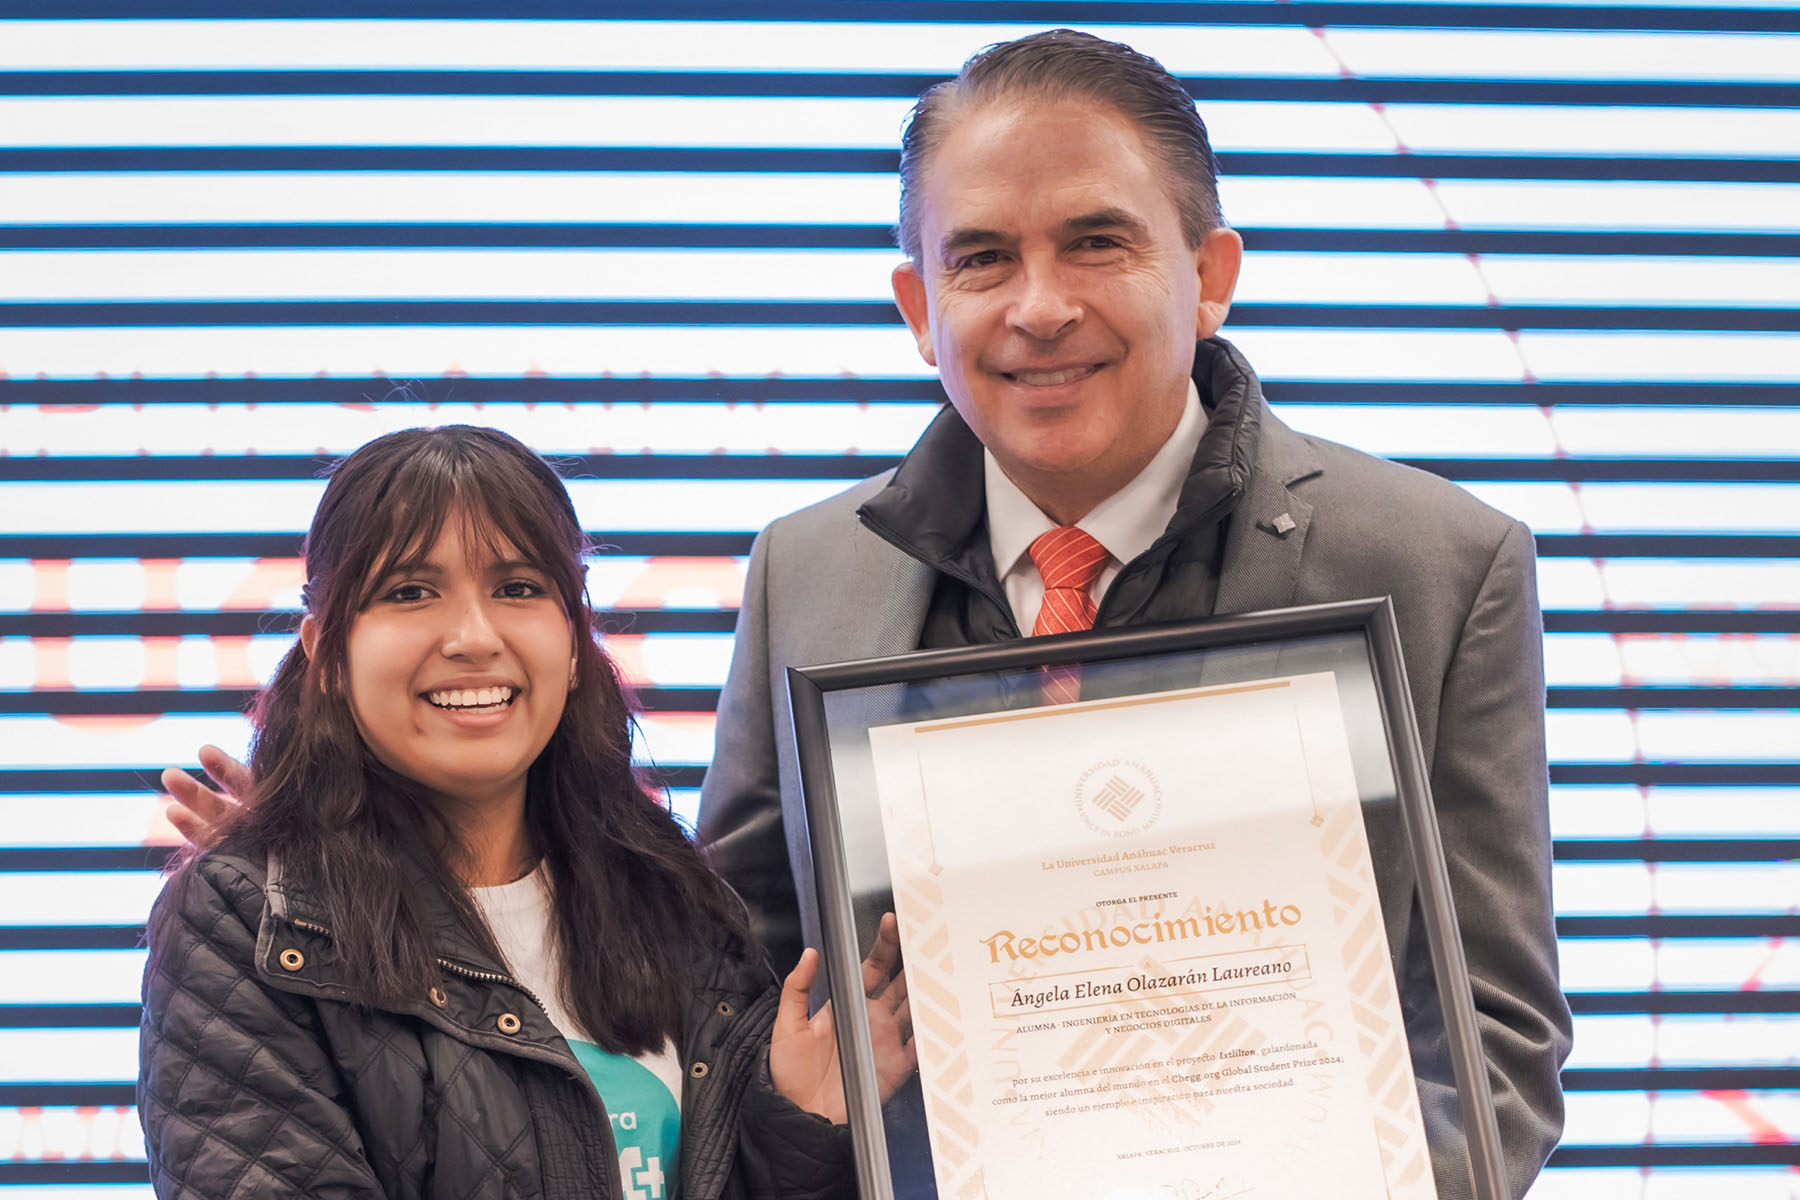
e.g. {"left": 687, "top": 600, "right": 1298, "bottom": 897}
{"left": 139, "top": 851, "right": 855, "bottom": 1200}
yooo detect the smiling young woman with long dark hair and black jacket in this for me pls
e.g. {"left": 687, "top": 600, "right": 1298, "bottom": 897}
{"left": 139, "top": 426, "right": 911, "bottom": 1200}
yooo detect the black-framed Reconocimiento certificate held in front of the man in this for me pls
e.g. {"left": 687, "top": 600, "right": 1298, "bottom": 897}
{"left": 788, "top": 597, "right": 1507, "bottom": 1200}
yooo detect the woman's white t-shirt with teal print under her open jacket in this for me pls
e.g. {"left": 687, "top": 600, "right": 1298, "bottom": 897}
{"left": 470, "top": 867, "right": 682, "bottom": 1200}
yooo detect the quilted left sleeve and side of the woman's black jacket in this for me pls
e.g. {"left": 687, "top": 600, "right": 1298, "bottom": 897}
{"left": 139, "top": 856, "right": 550, "bottom": 1200}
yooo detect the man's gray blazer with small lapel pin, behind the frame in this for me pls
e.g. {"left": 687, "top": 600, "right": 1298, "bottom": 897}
{"left": 700, "top": 351, "right": 1570, "bottom": 1196}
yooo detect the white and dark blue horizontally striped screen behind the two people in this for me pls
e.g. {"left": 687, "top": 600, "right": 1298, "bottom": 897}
{"left": 0, "top": 0, "right": 1800, "bottom": 1200}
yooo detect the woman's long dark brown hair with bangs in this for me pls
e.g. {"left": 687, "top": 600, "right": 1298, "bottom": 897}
{"left": 204, "top": 425, "right": 751, "bottom": 1052}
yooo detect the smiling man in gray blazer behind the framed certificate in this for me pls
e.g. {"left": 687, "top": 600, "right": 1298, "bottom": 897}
{"left": 700, "top": 31, "right": 1570, "bottom": 1195}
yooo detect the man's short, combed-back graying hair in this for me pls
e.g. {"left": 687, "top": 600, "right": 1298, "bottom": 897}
{"left": 895, "top": 29, "right": 1224, "bottom": 263}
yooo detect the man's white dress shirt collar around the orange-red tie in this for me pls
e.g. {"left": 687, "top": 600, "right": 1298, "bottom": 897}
{"left": 981, "top": 380, "right": 1206, "bottom": 633}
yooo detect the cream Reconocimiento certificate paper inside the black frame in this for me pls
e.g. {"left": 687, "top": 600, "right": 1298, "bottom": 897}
{"left": 869, "top": 675, "right": 1436, "bottom": 1200}
